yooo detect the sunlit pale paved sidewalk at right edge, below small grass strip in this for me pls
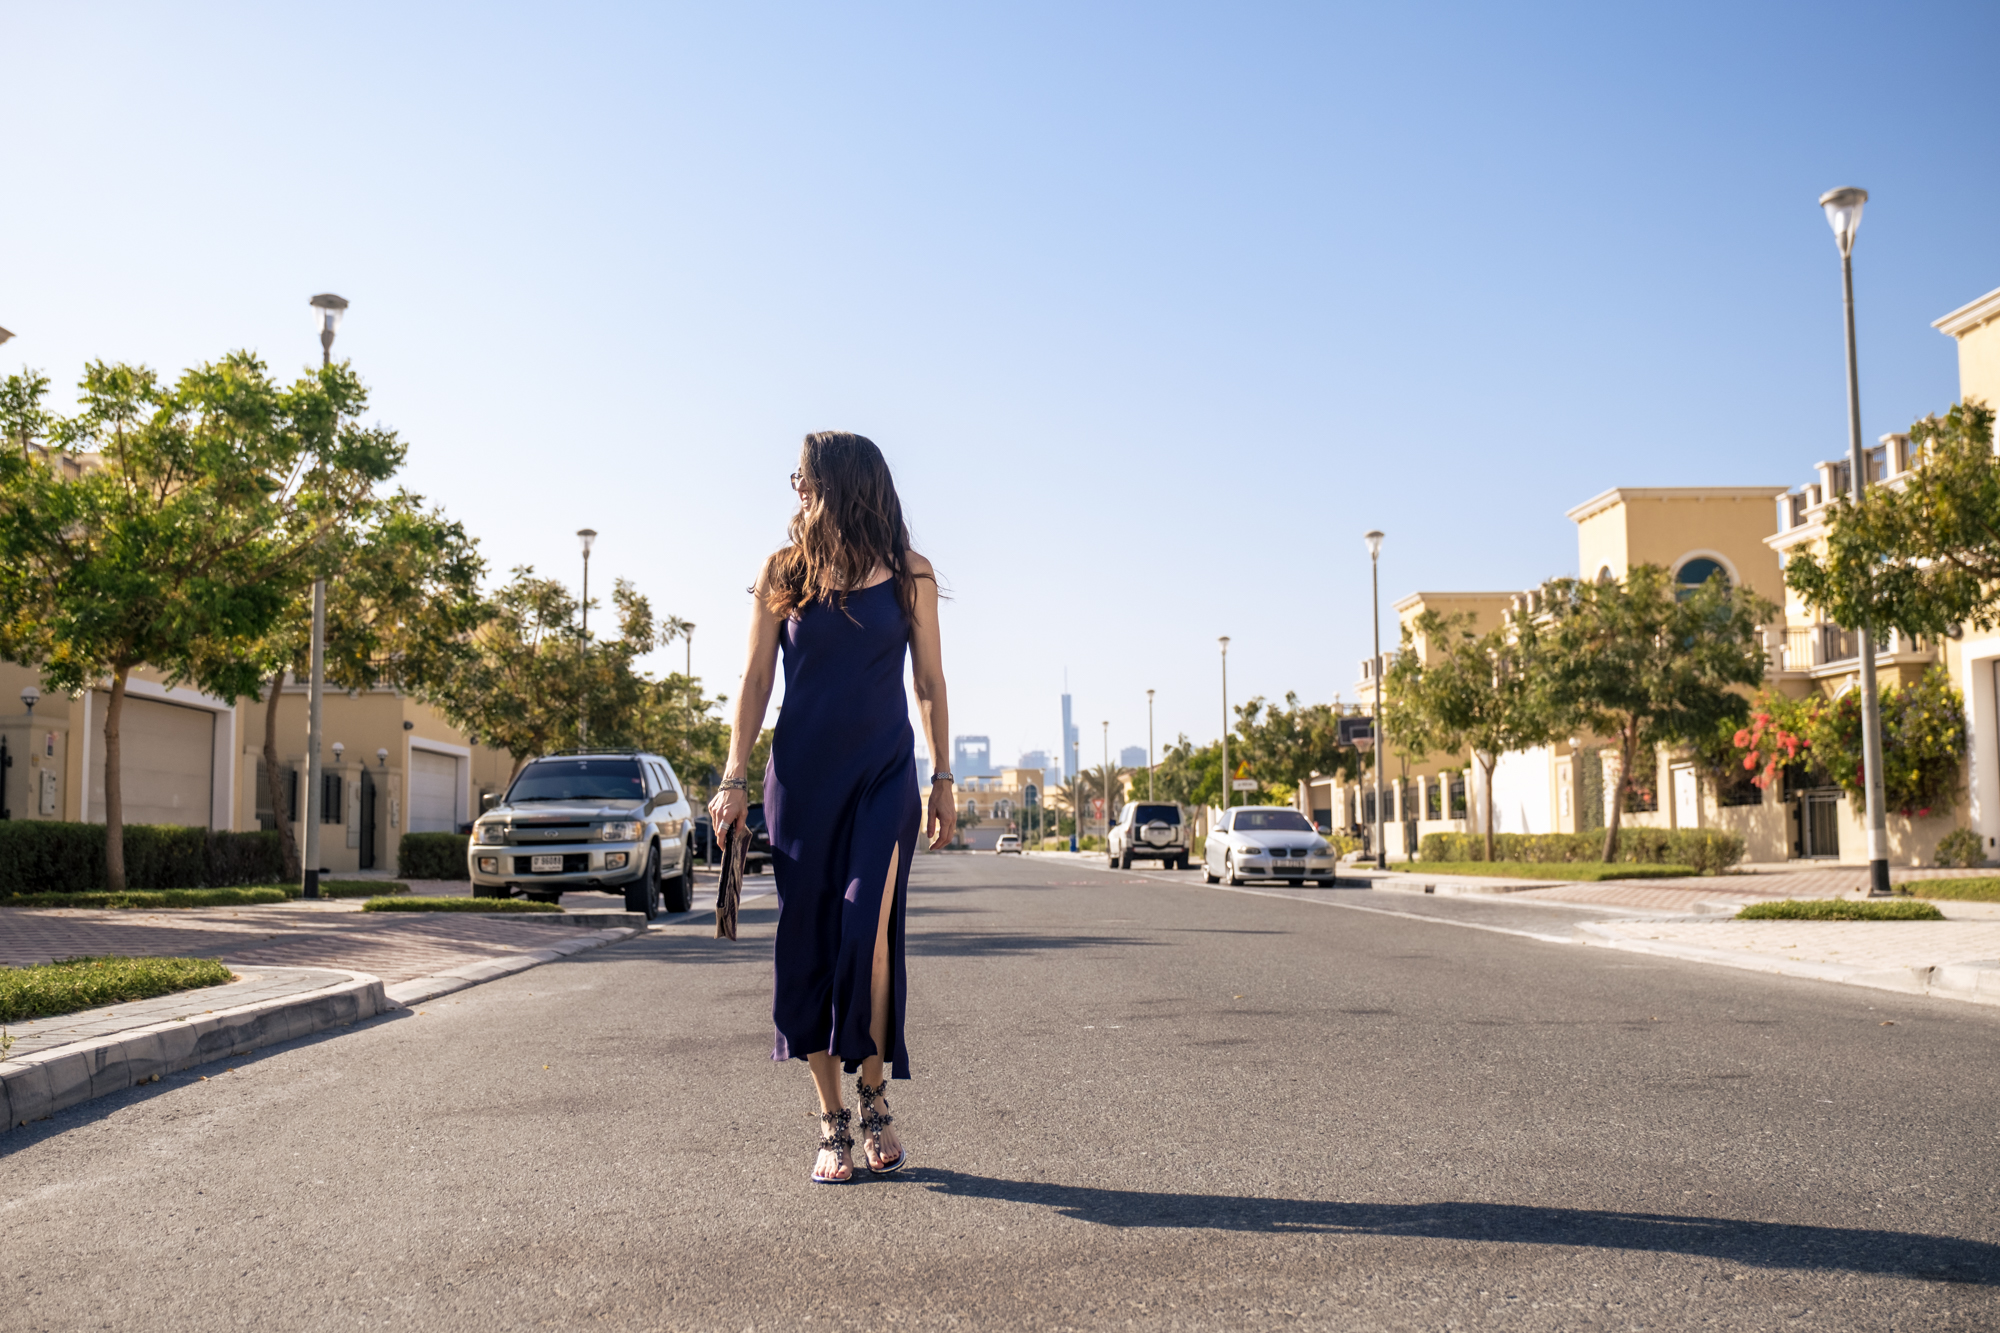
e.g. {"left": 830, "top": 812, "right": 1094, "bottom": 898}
{"left": 1592, "top": 921, "right": 2000, "bottom": 971}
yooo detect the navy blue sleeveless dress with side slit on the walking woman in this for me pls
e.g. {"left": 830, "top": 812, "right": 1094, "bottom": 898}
{"left": 764, "top": 578, "right": 920, "bottom": 1079}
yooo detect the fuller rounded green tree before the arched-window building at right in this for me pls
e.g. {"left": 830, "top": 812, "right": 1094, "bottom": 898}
{"left": 1536, "top": 564, "right": 1776, "bottom": 861}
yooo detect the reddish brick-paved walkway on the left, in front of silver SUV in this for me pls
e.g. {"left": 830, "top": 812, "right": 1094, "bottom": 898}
{"left": 0, "top": 901, "right": 616, "bottom": 985}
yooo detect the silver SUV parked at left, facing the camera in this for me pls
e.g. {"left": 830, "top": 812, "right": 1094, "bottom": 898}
{"left": 466, "top": 751, "right": 694, "bottom": 921}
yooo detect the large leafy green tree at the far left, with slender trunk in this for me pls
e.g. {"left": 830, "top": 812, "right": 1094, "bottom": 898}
{"left": 0, "top": 352, "right": 404, "bottom": 891}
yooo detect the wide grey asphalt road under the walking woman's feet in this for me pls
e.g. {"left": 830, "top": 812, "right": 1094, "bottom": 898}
{"left": 0, "top": 844, "right": 2000, "bottom": 1333}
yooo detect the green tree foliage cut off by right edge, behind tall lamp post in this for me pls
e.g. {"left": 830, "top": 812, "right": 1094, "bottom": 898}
{"left": 1784, "top": 398, "right": 2000, "bottom": 634}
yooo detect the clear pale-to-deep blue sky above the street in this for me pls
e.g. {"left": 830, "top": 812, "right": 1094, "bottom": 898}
{"left": 0, "top": 0, "right": 2000, "bottom": 761}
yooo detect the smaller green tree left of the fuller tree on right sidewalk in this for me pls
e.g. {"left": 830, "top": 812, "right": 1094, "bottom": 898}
{"left": 1384, "top": 612, "right": 1552, "bottom": 861}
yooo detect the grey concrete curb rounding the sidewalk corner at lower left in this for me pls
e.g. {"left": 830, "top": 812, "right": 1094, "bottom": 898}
{"left": 0, "top": 967, "right": 388, "bottom": 1133}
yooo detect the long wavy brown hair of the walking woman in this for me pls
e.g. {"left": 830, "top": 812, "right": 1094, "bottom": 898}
{"left": 764, "top": 430, "right": 916, "bottom": 624}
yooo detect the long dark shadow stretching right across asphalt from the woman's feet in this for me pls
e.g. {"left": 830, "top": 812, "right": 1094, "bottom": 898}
{"left": 910, "top": 1167, "right": 2000, "bottom": 1287}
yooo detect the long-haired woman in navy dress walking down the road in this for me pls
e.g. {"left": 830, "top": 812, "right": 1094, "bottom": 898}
{"left": 708, "top": 430, "right": 958, "bottom": 1185}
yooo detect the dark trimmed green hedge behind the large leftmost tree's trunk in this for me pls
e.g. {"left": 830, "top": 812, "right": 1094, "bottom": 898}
{"left": 0, "top": 819, "right": 284, "bottom": 901}
